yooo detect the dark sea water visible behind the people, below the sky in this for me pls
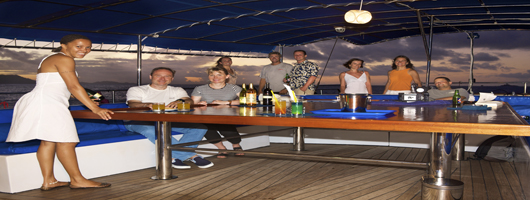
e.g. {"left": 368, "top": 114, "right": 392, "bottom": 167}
{"left": 0, "top": 84, "right": 524, "bottom": 109}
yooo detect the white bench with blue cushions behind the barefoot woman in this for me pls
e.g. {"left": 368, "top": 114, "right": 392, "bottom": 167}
{"left": 0, "top": 103, "right": 270, "bottom": 193}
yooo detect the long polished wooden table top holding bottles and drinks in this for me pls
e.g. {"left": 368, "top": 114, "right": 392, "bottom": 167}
{"left": 72, "top": 102, "right": 530, "bottom": 136}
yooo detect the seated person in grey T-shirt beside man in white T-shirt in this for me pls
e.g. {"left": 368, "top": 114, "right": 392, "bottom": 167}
{"left": 191, "top": 67, "right": 244, "bottom": 158}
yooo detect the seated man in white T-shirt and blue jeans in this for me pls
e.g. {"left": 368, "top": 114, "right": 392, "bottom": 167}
{"left": 125, "top": 67, "right": 213, "bottom": 169}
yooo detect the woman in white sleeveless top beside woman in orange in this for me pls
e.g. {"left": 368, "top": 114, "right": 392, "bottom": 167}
{"left": 339, "top": 58, "right": 372, "bottom": 94}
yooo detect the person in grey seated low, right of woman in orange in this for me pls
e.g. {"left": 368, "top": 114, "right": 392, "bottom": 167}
{"left": 428, "top": 77, "right": 469, "bottom": 101}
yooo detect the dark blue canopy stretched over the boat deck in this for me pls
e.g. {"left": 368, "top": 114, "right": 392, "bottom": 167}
{"left": 0, "top": 0, "right": 530, "bottom": 53}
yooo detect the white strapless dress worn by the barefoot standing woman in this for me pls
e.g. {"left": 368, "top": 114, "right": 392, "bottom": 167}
{"left": 6, "top": 54, "right": 79, "bottom": 142}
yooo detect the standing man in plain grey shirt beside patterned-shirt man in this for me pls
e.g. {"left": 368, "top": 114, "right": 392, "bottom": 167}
{"left": 258, "top": 52, "right": 293, "bottom": 96}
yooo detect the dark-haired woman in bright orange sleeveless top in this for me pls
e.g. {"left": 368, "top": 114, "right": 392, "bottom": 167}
{"left": 383, "top": 56, "right": 421, "bottom": 94}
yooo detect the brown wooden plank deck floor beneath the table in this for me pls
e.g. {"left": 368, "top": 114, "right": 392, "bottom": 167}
{"left": 0, "top": 144, "right": 525, "bottom": 200}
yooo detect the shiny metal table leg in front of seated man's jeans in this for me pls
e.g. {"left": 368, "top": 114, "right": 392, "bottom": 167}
{"left": 151, "top": 121, "right": 177, "bottom": 180}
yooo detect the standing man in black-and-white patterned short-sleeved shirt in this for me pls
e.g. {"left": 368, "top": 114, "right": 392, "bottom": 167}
{"left": 290, "top": 50, "right": 318, "bottom": 95}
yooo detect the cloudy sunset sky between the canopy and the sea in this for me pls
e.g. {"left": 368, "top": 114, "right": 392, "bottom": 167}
{"left": 0, "top": 31, "right": 530, "bottom": 85}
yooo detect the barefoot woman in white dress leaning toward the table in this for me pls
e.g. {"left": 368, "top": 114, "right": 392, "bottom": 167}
{"left": 6, "top": 34, "right": 113, "bottom": 190}
